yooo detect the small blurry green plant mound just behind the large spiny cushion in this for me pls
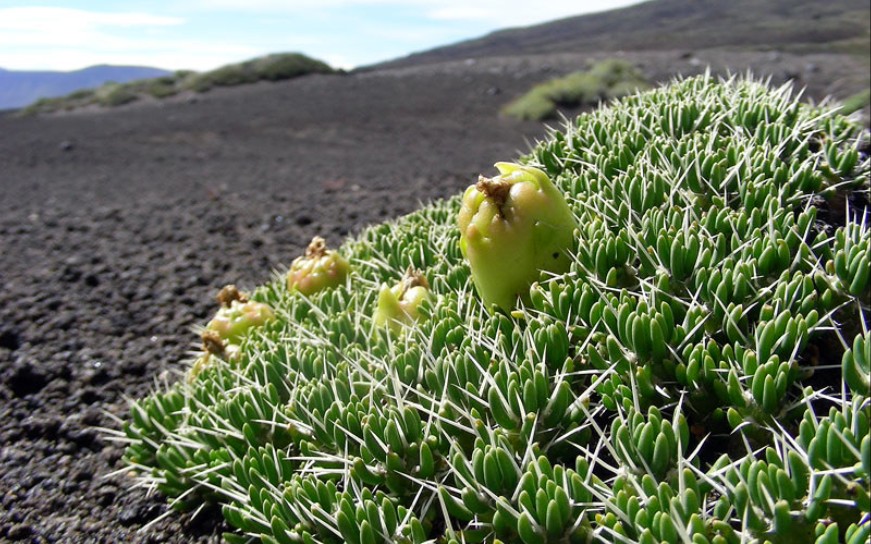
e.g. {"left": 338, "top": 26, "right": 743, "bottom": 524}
{"left": 502, "top": 59, "right": 650, "bottom": 121}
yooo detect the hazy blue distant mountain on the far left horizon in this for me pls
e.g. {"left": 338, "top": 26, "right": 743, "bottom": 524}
{"left": 0, "top": 65, "right": 172, "bottom": 109}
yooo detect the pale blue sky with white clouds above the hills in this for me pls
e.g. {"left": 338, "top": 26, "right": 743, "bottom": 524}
{"left": 0, "top": 0, "right": 640, "bottom": 70}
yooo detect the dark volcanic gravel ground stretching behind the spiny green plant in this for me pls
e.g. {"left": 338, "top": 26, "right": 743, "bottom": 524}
{"left": 0, "top": 51, "right": 868, "bottom": 543}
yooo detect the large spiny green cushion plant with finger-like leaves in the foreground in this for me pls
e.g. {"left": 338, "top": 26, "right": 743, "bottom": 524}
{"left": 122, "top": 73, "right": 871, "bottom": 544}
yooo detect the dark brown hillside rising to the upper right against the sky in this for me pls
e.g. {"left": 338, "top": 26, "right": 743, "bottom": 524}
{"left": 378, "top": 0, "right": 871, "bottom": 67}
